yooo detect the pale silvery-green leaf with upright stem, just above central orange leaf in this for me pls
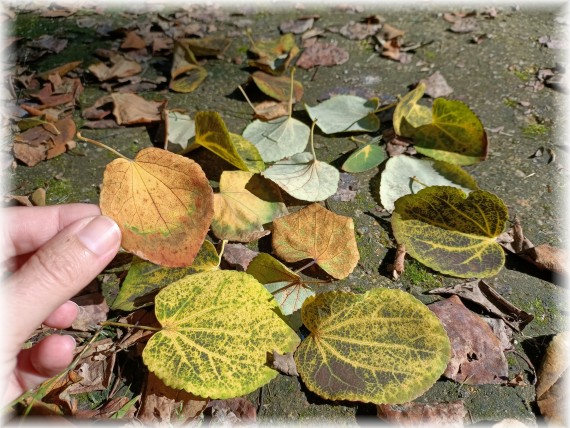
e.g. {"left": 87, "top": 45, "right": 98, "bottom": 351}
{"left": 262, "top": 152, "right": 340, "bottom": 202}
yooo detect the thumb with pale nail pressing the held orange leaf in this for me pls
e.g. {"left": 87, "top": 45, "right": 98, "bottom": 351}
{"left": 5, "top": 216, "right": 121, "bottom": 346}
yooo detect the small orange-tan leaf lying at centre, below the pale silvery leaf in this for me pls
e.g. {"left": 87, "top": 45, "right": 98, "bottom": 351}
{"left": 272, "top": 204, "right": 360, "bottom": 279}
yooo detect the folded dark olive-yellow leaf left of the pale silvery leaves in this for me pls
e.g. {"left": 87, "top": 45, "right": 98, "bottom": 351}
{"left": 194, "top": 111, "right": 249, "bottom": 171}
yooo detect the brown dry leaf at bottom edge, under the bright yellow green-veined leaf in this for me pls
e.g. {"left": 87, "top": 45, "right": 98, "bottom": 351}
{"left": 137, "top": 372, "right": 209, "bottom": 425}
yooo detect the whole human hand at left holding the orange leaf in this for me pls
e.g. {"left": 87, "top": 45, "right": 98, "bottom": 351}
{"left": 0, "top": 204, "right": 121, "bottom": 405}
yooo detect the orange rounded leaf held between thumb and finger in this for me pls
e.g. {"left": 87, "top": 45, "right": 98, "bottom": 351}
{"left": 99, "top": 147, "right": 214, "bottom": 267}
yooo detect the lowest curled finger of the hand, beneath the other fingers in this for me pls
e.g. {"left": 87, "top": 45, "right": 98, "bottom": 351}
{"left": 4, "top": 334, "right": 75, "bottom": 401}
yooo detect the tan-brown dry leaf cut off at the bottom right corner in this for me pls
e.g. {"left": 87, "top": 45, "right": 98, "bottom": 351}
{"left": 536, "top": 332, "right": 570, "bottom": 426}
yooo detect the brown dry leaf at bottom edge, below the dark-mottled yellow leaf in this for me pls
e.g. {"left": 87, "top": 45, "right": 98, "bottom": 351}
{"left": 376, "top": 400, "right": 467, "bottom": 427}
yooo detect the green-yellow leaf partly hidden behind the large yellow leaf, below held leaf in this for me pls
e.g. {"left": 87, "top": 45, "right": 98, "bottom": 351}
{"left": 111, "top": 241, "right": 220, "bottom": 311}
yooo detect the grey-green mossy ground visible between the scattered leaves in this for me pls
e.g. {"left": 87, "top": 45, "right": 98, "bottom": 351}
{"left": 9, "top": 2, "right": 568, "bottom": 425}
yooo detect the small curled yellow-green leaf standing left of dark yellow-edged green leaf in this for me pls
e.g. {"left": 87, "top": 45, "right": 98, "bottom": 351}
{"left": 392, "top": 83, "right": 432, "bottom": 137}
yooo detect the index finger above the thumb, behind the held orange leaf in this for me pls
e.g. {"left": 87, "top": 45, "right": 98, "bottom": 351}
{"left": 0, "top": 204, "right": 101, "bottom": 260}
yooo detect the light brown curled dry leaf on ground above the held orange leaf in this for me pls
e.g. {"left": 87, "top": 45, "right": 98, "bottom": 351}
{"left": 111, "top": 93, "right": 166, "bottom": 125}
